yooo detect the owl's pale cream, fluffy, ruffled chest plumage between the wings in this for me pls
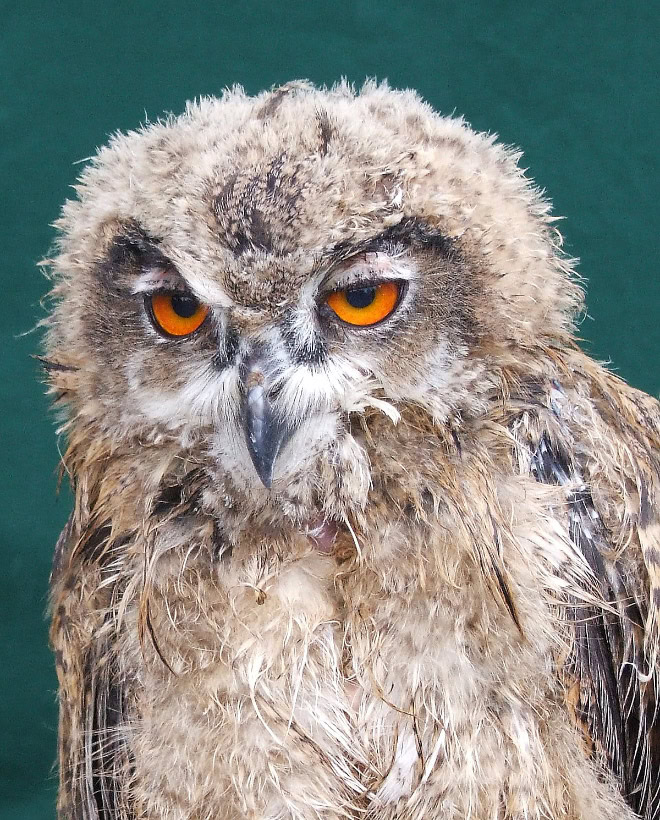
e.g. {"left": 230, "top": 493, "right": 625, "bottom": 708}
{"left": 120, "top": 500, "right": 612, "bottom": 818}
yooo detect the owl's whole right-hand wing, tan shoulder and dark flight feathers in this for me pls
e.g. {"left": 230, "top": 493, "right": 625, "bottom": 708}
{"left": 531, "top": 363, "right": 660, "bottom": 820}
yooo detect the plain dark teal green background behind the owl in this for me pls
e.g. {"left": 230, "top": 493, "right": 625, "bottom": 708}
{"left": 0, "top": 0, "right": 660, "bottom": 820}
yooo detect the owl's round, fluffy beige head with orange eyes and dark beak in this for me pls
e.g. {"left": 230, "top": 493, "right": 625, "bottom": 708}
{"left": 47, "top": 83, "right": 580, "bottom": 528}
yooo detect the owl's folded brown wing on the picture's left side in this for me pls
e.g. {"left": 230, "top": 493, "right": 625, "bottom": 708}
{"left": 51, "top": 519, "right": 134, "bottom": 820}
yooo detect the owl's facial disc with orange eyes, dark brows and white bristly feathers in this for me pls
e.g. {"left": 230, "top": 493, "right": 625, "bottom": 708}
{"left": 84, "top": 215, "right": 474, "bottom": 490}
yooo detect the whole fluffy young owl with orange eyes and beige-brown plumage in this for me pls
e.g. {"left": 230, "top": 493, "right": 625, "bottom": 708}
{"left": 43, "top": 82, "right": 660, "bottom": 820}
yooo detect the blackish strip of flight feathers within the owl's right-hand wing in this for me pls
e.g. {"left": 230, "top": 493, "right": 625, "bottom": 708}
{"left": 532, "top": 434, "right": 660, "bottom": 820}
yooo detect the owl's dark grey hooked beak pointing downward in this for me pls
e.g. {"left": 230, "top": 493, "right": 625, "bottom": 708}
{"left": 241, "top": 359, "right": 293, "bottom": 489}
